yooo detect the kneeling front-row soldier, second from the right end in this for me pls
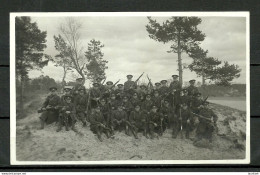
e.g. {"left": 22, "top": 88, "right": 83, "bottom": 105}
{"left": 177, "top": 103, "right": 194, "bottom": 139}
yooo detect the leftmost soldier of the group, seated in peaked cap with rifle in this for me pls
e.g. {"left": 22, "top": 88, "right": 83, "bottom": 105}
{"left": 38, "top": 87, "right": 60, "bottom": 129}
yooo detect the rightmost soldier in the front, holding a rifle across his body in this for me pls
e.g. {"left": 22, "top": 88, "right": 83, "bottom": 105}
{"left": 196, "top": 102, "right": 218, "bottom": 142}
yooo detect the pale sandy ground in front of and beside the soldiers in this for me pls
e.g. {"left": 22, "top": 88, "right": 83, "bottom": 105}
{"left": 16, "top": 95, "right": 246, "bottom": 161}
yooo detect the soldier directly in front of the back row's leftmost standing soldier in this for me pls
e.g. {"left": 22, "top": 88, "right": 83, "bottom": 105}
{"left": 74, "top": 88, "right": 89, "bottom": 127}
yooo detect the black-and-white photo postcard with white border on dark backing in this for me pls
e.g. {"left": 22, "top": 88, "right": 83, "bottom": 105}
{"left": 10, "top": 12, "right": 250, "bottom": 165}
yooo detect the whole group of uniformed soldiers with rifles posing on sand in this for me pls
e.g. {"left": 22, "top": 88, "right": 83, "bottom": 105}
{"left": 39, "top": 74, "right": 217, "bottom": 141}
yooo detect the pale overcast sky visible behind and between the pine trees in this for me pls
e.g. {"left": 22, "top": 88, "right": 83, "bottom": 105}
{"left": 29, "top": 16, "right": 246, "bottom": 86}
